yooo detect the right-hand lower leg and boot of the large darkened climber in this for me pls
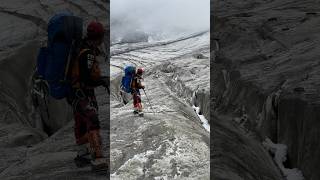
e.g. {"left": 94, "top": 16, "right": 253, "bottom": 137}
{"left": 89, "top": 130, "right": 108, "bottom": 172}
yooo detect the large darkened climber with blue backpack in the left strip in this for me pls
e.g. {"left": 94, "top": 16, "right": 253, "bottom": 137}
{"left": 34, "top": 13, "right": 109, "bottom": 171}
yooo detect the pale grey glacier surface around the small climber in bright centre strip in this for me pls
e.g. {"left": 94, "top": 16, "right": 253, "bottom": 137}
{"left": 110, "top": 33, "right": 210, "bottom": 179}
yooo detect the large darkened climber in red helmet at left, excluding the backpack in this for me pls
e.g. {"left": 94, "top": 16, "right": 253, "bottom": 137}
{"left": 68, "top": 21, "right": 109, "bottom": 171}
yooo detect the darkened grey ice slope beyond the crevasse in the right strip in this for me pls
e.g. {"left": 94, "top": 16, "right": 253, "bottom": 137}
{"left": 213, "top": 0, "right": 320, "bottom": 180}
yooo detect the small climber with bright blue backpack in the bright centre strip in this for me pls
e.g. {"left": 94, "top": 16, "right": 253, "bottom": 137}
{"left": 121, "top": 66, "right": 145, "bottom": 116}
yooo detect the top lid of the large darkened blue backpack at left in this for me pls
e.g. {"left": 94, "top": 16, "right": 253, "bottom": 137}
{"left": 47, "top": 12, "right": 83, "bottom": 44}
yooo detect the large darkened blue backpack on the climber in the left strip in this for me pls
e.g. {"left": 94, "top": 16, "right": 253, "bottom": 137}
{"left": 36, "top": 13, "right": 83, "bottom": 99}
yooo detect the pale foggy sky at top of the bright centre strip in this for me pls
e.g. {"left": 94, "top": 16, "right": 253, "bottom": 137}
{"left": 110, "top": 0, "right": 210, "bottom": 40}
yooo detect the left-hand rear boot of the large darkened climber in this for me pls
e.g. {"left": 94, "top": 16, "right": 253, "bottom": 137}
{"left": 74, "top": 144, "right": 91, "bottom": 168}
